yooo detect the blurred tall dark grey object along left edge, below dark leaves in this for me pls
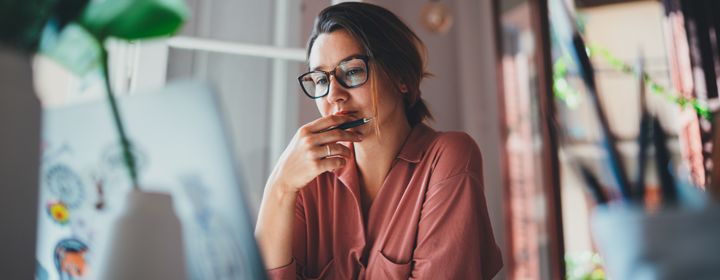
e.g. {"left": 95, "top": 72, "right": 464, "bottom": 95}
{"left": 0, "top": 45, "right": 41, "bottom": 279}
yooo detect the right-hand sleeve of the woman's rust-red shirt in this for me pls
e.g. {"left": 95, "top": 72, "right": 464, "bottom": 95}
{"left": 411, "top": 139, "right": 503, "bottom": 280}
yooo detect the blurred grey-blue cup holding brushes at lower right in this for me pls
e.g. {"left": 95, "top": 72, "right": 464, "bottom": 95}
{"left": 592, "top": 205, "right": 720, "bottom": 280}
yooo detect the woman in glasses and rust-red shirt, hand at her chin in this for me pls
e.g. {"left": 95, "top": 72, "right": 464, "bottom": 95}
{"left": 255, "top": 2, "right": 502, "bottom": 279}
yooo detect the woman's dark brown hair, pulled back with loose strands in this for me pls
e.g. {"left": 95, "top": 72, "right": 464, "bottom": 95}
{"left": 307, "top": 2, "right": 433, "bottom": 129}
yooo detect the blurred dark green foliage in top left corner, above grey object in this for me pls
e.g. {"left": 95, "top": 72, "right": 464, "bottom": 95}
{"left": 0, "top": 0, "right": 56, "bottom": 52}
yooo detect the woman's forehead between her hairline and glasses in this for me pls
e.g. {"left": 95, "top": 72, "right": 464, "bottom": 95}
{"left": 308, "top": 29, "right": 366, "bottom": 71}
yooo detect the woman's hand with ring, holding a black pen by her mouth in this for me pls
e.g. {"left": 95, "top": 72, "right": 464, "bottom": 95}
{"left": 266, "top": 115, "right": 363, "bottom": 195}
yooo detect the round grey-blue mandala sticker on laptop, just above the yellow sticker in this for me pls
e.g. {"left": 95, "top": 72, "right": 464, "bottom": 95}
{"left": 43, "top": 164, "right": 85, "bottom": 209}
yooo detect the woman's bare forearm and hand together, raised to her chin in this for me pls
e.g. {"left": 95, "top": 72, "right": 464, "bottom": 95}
{"left": 255, "top": 115, "right": 363, "bottom": 269}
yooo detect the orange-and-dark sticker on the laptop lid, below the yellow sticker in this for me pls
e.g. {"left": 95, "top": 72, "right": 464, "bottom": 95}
{"left": 55, "top": 239, "right": 90, "bottom": 280}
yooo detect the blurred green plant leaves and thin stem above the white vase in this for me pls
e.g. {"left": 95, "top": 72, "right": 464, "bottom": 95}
{"left": 0, "top": 0, "right": 190, "bottom": 188}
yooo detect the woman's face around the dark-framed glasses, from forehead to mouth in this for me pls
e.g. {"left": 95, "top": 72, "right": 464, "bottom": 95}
{"left": 309, "top": 29, "right": 407, "bottom": 138}
